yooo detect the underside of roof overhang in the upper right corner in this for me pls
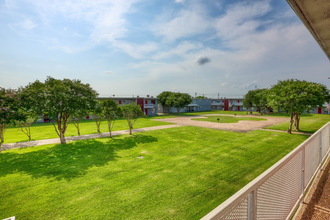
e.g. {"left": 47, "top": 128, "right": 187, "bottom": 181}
{"left": 287, "top": 0, "right": 330, "bottom": 60}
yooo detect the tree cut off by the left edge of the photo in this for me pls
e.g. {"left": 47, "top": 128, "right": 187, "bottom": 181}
{"left": 0, "top": 87, "right": 25, "bottom": 152}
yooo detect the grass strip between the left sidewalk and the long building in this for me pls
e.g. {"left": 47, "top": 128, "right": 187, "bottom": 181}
{"left": 4, "top": 116, "right": 175, "bottom": 144}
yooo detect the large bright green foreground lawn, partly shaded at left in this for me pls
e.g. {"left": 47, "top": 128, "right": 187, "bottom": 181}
{"left": 0, "top": 126, "right": 307, "bottom": 220}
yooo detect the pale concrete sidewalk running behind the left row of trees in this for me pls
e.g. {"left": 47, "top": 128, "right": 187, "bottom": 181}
{"left": 2, "top": 124, "right": 183, "bottom": 150}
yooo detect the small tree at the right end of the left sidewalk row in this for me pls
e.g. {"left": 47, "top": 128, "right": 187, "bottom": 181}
{"left": 121, "top": 102, "right": 146, "bottom": 135}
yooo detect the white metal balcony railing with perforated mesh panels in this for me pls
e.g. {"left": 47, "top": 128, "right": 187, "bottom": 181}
{"left": 202, "top": 122, "right": 330, "bottom": 220}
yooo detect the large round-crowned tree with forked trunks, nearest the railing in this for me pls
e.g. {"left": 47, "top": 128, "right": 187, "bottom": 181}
{"left": 267, "top": 79, "right": 327, "bottom": 134}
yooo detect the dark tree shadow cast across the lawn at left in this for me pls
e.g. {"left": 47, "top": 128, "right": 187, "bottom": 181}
{"left": 0, "top": 134, "right": 158, "bottom": 180}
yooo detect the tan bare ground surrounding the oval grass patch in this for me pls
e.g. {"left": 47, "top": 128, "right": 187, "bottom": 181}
{"left": 154, "top": 114, "right": 289, "bottom": 133}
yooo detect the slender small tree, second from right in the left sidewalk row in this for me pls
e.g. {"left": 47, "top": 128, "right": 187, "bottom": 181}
{"left": 102, "top": 99, "right": 122, "bottom": 138}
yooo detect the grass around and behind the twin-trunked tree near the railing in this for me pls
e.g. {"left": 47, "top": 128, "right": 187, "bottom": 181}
{"left": 266, "top": 113, "right": 330, "bottom": 133}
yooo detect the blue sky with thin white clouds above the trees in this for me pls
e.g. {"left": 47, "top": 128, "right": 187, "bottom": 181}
{"left": 0, "top": 0, "right": 330, "bottom": 97}
